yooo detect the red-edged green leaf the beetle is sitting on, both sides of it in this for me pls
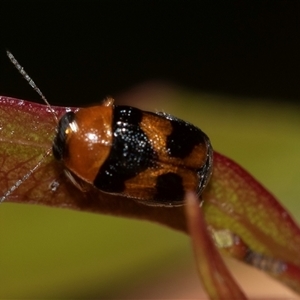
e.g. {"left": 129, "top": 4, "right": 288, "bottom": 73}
{"left": 0, "top": 96, "right": 300, "bottom": 291}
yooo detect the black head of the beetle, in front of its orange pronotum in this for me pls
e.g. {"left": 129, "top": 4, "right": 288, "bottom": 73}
{"left": 52, "top": 111, "right": 75, "bottom": 160}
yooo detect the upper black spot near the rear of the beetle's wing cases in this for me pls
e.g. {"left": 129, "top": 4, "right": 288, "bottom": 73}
{"left": 166, "top": 117, "right": 206, "bottom": 159}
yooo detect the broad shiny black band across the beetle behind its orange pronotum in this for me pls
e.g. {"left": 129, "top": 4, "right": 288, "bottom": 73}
{"left": 94, "top": 106, "right": 157, "bottom": 193}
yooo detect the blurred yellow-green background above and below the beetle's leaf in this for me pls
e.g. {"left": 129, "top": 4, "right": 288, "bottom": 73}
{"left": 0, "top": 83, "right": 300, "bottom": 299}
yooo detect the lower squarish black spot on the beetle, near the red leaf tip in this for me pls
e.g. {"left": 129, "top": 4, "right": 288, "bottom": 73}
{"left": 154, "top": 172, "right": 185, "bottom": 203}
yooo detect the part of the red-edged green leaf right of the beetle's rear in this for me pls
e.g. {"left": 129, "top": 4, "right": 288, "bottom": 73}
{"left": 203, "top": 153, "right": 300, "bottom": 293}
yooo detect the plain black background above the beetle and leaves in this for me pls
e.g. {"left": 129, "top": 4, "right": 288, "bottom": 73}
{"left": 0, "top": 0, "right": 300, "bottom": 105}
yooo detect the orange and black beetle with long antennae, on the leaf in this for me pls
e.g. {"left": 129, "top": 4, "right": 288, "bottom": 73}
{"left": 2, "top": 52, "right": 213, "bottom": 207}
